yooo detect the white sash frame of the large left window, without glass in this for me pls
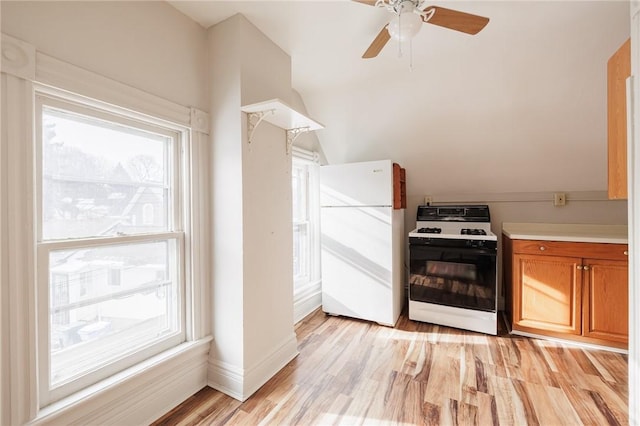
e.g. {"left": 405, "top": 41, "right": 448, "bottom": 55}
{"left": 34, "top": 89, "right": 192, "bottom": 408}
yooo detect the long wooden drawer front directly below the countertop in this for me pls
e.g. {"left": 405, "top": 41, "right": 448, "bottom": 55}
{"left": 513, "top": 240, "right": 629, "bottom": 260}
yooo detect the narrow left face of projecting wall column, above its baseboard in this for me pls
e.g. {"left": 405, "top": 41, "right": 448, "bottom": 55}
{"left": 208, "top": 13, "right": 244, "bottom": 376}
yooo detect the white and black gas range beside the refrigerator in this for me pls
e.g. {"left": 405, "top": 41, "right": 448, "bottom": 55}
{"left": 409, "top": 205, "right": 498, "bottom": 335}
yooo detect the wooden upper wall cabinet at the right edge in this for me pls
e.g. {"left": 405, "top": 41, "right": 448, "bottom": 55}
{"left": 607, "top": 39, "right": 631, "bottom": 199}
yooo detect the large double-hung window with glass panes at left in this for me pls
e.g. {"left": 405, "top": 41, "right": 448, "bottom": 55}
{"left": 36, "top": 94, "right": 186, "bottom": 405}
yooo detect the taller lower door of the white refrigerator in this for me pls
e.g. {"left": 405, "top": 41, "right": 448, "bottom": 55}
{"left": 321, "top": 207, "right": 401, "bottom": 326}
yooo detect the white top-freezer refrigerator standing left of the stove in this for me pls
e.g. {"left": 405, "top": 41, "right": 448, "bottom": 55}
{"left": 320, "top": 160, "right": 405, "bottom": 326}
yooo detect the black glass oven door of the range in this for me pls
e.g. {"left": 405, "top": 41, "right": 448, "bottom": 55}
{"left": 409, "top": 240, "right": 497, "bottom": 312}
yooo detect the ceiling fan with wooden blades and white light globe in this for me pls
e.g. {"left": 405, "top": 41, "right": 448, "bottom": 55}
{"left": 353, "top": 0, "right": 489, "bottom": 59}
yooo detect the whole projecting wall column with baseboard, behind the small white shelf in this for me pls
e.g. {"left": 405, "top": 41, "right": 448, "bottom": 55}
{"left": 208, "top": 15, "right": 297, "bottom": 400}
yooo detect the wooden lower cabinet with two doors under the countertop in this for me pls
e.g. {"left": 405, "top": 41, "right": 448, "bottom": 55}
{"left": 503, "top": 237, "right": 629, "bottom": 348}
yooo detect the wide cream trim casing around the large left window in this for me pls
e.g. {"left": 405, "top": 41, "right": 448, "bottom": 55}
{"left": 0, "top": 39, "right": 212, "bottom": 424}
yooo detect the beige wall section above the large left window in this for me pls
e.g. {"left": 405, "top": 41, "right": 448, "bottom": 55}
{"left": 0, "top": 1, "right": 208, "bottom": 109}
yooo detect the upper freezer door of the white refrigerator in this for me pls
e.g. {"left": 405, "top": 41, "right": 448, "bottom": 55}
{"left": 320, "top": 160, "right": 393, "bottom": 207}
